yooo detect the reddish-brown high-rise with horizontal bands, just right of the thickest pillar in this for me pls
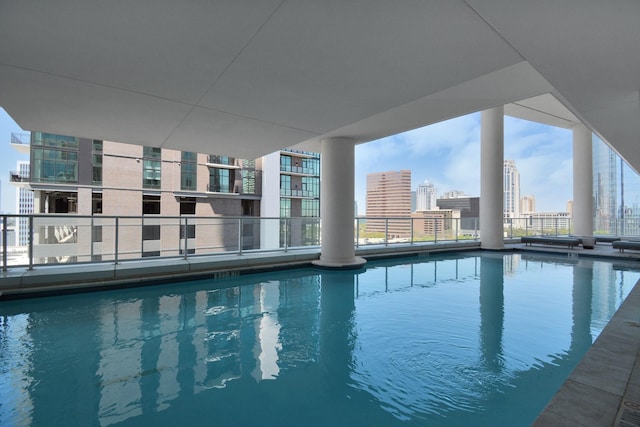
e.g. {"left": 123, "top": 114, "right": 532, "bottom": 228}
{"left": 367, "top": 170, "right": 411, "bottom": 237}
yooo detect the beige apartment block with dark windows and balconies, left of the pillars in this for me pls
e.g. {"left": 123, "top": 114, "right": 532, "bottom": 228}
{"left": 11, "top": 132, "right": 320, "bottom": 262}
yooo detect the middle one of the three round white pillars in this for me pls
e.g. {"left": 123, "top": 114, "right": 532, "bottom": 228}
{"left": 480, "top": 107, "right": 504, "bottom": 249}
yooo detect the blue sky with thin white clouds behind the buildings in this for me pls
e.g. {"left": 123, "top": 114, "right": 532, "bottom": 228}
{"left": 0, "top": 108, "right": 573, "bottom": 215}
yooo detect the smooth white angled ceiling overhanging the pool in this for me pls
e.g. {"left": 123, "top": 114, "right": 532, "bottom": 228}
{"left": 0, "top": 0, "right": 640, "bottom": 169}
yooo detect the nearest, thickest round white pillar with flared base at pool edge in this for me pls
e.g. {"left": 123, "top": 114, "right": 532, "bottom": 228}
{"left": 314, "top": 138, "right": 366, "bottom": 268}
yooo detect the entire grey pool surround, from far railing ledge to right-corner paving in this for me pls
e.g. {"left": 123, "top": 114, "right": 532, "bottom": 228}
{"left": 0, "top": 241, "right": 640, "bottom": 427}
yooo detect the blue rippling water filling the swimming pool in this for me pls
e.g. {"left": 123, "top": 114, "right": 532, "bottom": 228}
{"left": 0, "top": 253, "right": 640, "bottom": 426}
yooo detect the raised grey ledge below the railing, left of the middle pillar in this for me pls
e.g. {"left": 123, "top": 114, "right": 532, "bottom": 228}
{"left": 0, "top": 241, "right": 480, "bottom": 301}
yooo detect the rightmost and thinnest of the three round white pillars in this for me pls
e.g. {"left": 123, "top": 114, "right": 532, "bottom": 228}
{"left": 572, "top": 123, "right": 593, "bottom": 236}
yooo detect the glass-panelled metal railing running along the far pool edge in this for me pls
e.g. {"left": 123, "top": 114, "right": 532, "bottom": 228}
{"left": 0, "top": 214, "right": 640, "bottom": 271}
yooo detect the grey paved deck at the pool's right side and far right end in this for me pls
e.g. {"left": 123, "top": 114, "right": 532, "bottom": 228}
{"left": 507, "top": 243, "right": 640, "bottom": 427}
